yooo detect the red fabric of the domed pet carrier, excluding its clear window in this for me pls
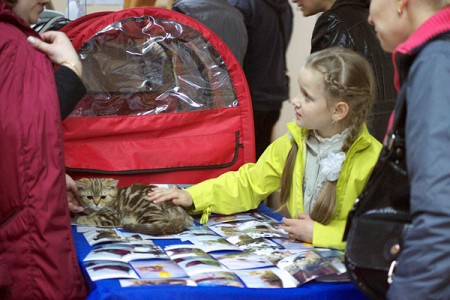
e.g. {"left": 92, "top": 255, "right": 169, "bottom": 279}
{"left": 62, "top": 7, "right": 255, "bottom": 185}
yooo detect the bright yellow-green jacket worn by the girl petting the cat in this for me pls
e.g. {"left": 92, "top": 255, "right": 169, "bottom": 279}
{"left": 187, "top": 122, "right": 381, "bottom": 250}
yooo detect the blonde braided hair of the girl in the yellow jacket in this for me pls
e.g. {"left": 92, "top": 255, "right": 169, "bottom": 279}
{"left": 280, "top": 47, "right": 376, "bottom": 224}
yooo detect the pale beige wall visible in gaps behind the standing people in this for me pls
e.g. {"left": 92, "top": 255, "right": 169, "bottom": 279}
{"left": 52, "top": 0, "right": 316, "bottom": 142}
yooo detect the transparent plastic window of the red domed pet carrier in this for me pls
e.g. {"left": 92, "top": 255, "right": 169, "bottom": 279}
{"left": 71, "top": 16, "right": 238, "bottom": 117}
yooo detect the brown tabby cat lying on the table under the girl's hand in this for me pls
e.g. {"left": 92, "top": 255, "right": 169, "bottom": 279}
{"left": 74, "top": 178, "right": 193, "bottom": 235}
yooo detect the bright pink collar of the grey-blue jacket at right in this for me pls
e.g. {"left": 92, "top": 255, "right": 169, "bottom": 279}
{"left": 393, "top": 7, "right": 450, "bottom": 90}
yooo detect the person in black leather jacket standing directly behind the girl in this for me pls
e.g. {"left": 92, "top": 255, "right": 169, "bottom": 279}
{"left": 292, "top": 0, "right": 397, "bottom": 142}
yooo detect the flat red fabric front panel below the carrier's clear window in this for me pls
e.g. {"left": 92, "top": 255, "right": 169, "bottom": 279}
{"left": 64, "top": 107, "right": 244, "bottom": 182}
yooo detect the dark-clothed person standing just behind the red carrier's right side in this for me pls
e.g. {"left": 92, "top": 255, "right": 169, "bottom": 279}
{"left": 228, "top": 0, "right": 294, "bottom": 158}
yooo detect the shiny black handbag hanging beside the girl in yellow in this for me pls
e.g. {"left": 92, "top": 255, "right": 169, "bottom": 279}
{"left": 344, "top": 92, "right": 411, "bottom": 299}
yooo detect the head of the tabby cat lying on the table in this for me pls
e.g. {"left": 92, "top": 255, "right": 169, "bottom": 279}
{"left": 75, "top": 178, "right": 119, "bottom": 210}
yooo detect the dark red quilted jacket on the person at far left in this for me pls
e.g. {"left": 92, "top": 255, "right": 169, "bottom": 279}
{"left": 0, "top": 0, "right": 86, "bottom": 299}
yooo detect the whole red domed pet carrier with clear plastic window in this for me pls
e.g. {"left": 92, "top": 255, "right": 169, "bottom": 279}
{"left": 61, "top": 7, "right": 255, "bottom": 185}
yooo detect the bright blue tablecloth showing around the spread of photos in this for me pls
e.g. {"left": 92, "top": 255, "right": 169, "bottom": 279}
{"left": 72, "top": 204, "right": 367, "bottom": 300}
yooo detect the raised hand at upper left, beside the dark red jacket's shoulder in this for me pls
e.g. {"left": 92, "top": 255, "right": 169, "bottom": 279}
{"left": 27, "top": 31, "right": 82, "bottom": 77}
